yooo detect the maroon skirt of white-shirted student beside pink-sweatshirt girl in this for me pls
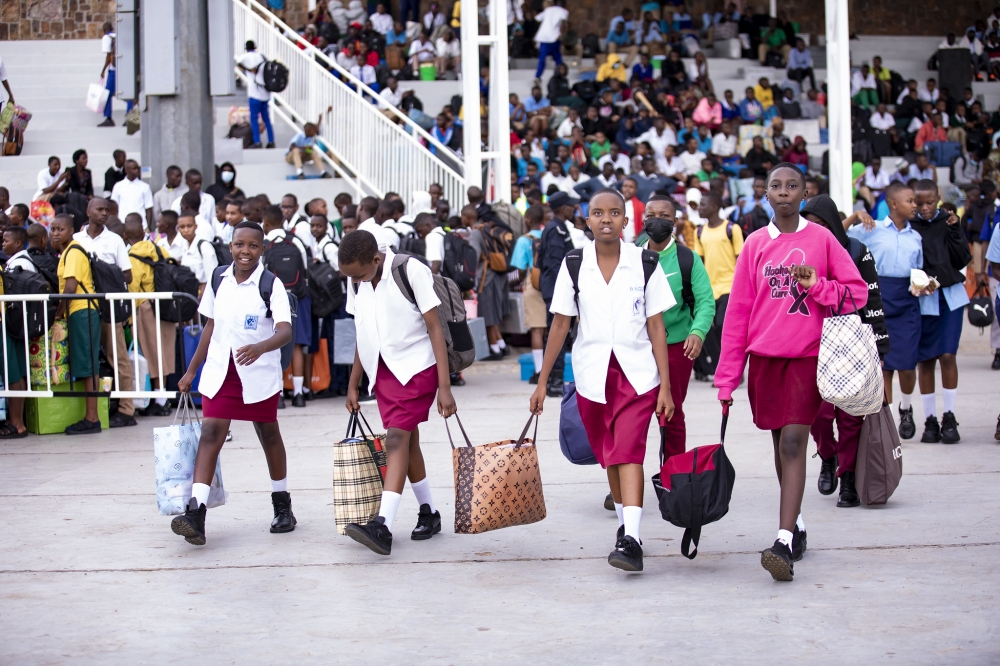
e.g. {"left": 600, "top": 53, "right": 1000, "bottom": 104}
{"left": 576, "top": 354, "right": 660, "bottom": 469}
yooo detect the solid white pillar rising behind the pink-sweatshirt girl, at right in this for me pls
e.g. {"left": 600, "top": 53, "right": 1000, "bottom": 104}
{"left": 826, "top": 0, "right": 854, "bottom": 215}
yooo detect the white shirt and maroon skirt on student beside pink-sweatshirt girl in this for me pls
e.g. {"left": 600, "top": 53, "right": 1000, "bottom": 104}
{"left": 549, "top": 243, "right": 676, "bottom": 468}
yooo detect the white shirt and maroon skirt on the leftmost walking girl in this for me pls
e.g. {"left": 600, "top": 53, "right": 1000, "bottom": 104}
{"left": 198, "top": 263, "right": 292, "bottom": 423}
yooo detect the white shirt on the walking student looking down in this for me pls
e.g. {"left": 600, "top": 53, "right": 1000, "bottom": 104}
{"left": 347, "top": 250, "right": 441, "bottom": 388}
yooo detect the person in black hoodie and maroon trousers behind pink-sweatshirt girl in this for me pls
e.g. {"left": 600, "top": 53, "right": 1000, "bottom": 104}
{"left": 802, "top": 193, "right": 892, "bottom": 508}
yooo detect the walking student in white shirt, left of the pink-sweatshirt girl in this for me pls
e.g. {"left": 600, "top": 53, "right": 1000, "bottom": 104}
{"left": 529, "top": 189, "right": 676, "bottom": 571}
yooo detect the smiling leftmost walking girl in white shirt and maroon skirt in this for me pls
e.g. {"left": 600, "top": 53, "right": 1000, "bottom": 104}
{"left": 170, "top": 221, "right": 296, "bottom": 546}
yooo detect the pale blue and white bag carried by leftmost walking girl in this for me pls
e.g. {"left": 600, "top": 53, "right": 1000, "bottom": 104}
{"left": 153, "top": 393, "right": 226, "bottom": 516}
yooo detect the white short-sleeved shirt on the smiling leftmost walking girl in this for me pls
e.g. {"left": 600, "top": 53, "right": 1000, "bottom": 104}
{"left": 198, "top": 263, "right": 292, "bottom": 404}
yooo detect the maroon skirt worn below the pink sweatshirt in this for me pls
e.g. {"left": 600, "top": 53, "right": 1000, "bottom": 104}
{"left": 747, "top": 354, "right": 823, "bottom": 430}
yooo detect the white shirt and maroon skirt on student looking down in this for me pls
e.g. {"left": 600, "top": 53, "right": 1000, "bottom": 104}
{"left": 347, "top": 249, "right": 441, "bottom": 431}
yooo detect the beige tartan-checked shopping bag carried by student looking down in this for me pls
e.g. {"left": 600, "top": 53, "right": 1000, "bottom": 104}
{"left": 333, "top": 411, "right": 386, "bottom": 534}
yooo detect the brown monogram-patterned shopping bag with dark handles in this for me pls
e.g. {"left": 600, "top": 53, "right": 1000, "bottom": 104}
{"left": 444, "top": 414, "right": 545, "bottom": 534}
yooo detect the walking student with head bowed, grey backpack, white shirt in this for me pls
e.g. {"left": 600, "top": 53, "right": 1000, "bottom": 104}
{"left": 339, "top": 230, "right": 456, "bottom": 555}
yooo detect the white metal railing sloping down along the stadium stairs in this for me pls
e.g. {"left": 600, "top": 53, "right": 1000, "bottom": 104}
{"left": 232, "top": 0, "right": 466, "bottom": 206}
